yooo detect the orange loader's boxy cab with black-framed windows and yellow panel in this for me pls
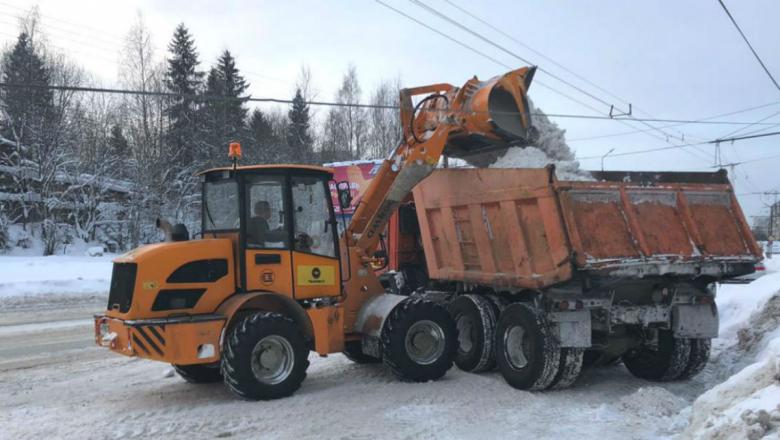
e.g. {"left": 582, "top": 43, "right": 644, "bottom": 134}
{"left": 201, "top": 165, "right": 341, "bottom": 300}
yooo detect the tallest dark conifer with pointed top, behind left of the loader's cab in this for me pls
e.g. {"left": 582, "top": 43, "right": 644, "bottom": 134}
{"left": 165, "top": 23, "right": 203, "bottom": 166}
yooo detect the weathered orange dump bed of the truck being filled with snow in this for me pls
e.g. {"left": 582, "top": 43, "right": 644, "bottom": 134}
{"left": 414, "top": 167, "right": 762, "bottom": 288}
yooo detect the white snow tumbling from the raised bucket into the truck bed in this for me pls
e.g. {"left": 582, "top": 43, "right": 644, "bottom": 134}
{"left": 469, "top": 100, "right": 593, "bottom": 180}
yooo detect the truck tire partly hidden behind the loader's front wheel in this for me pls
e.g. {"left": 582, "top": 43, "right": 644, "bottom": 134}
{"left": 447, "top": 295, "right": 498, "bottom": 373}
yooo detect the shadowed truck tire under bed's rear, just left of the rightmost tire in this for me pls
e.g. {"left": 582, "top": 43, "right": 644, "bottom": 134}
{"left": 623, "top": 330, "right": 691, "bottom": 382}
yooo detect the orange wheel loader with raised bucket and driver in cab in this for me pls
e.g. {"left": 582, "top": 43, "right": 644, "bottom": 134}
{"left": 95, "top": 67, "right": 535, "bottom": 399}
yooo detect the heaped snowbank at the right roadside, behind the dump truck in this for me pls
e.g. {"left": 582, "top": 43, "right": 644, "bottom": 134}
{"left": 684, "top": 259, "right": 780, "bottom": 439}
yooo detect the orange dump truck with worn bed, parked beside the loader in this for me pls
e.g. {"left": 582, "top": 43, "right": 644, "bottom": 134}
{"left": 389, "top": 167, "right": 762, "bottom": 389}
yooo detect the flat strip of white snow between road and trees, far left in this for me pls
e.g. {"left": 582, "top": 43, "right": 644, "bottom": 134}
{"left": 0, "top": 255, "right": 112, "bottom": 298}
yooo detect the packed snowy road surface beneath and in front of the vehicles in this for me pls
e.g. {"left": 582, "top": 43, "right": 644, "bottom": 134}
{"left": 0, "top": 304, "right": 703, "bottom": 439}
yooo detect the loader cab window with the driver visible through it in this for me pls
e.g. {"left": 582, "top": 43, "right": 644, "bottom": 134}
{"left": 246, "top": 176, "right": 290, "bottom": 249}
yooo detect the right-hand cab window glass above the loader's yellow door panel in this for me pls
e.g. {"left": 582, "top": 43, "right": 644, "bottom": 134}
{"left": 292, "top": 176, "right": 336, "bottom": 257}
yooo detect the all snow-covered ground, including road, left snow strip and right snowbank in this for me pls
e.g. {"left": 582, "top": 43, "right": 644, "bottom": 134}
{"left": 0, "top": 253, "right": 780, "bottom": 440}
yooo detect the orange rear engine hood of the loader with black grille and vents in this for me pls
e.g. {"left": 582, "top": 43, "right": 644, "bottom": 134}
{"left": 106, "top": 239, "right": 236, "bottom": 320}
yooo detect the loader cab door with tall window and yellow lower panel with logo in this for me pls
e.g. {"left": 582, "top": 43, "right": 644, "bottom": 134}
{"left": 290, "top": 173, "right": 341, "bottom": 299}
